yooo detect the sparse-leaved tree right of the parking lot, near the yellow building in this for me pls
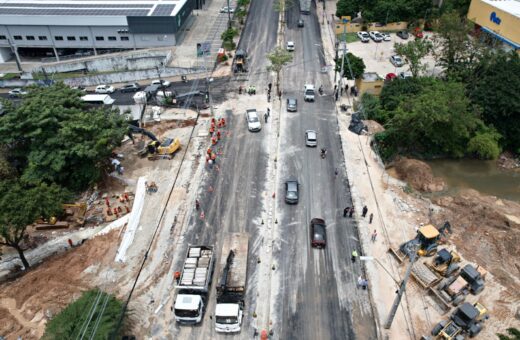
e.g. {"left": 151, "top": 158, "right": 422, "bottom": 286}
{"left": 434, "top": 11, "right": 486, "bottom": 82}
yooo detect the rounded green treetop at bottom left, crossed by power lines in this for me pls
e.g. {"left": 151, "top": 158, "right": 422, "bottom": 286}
{"left": 42, "top": 289, "right": 123, "bottom": 340}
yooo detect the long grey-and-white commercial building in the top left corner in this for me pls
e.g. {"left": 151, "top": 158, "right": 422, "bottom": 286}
{"left": 0, "top": 0, "right": 199, "bottom": 62}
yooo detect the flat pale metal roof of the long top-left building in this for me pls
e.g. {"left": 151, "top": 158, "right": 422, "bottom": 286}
{"left": 0, "top": 0, "right": 187, "bottom": 17}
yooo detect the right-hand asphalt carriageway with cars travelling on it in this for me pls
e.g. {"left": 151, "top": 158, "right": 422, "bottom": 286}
{"left": 276, "top": 1, "right": 376, "bottom": 339}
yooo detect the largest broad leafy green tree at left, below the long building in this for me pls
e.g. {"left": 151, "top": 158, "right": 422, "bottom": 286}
{"left": 0, "top": 84, "right": 126, "bottom": 191}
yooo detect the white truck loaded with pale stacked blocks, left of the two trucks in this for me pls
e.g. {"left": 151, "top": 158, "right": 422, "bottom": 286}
{"left": 174, "top": 245, "right": 215, "bottom": 324}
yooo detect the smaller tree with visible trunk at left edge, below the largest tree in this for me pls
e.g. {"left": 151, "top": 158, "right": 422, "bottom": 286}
{"left": 0, "top": 180, "right": 70, "bottom": 269}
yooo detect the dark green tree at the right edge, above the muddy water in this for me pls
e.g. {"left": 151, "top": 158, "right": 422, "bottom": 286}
{"left": 466, "top": 51, "right": 520, "bottom": 153}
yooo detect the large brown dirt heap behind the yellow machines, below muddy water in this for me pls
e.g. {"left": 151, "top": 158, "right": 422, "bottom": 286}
{"left": 432, "top": 189, "right": 520, "bottom": 289}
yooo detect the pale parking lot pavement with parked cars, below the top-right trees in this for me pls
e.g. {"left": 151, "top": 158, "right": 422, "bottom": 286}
{"left": 347, "top": 33, "right": 440, "bottom": 78}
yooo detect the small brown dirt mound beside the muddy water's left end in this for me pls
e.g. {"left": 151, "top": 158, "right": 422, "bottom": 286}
{"left": 393, "top": 157, "right": 446, "bottom": 192}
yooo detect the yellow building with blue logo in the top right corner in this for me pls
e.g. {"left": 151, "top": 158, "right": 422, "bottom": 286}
{"left": 468, "top": 0, "right": 520, "bottom": 52}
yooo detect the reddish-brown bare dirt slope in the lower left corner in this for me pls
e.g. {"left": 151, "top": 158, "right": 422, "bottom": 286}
{"left": 0, "top": 231, "right": 118, "bottom": 339}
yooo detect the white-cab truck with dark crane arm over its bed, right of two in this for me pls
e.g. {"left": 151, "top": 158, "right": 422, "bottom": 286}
{"left": 215, "top": 233, "right": 249, "bottom": 333}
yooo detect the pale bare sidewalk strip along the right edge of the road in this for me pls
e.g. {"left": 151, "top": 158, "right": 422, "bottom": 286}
{"left": 317, "top": 1, "right": 433, "bottom": 339}
